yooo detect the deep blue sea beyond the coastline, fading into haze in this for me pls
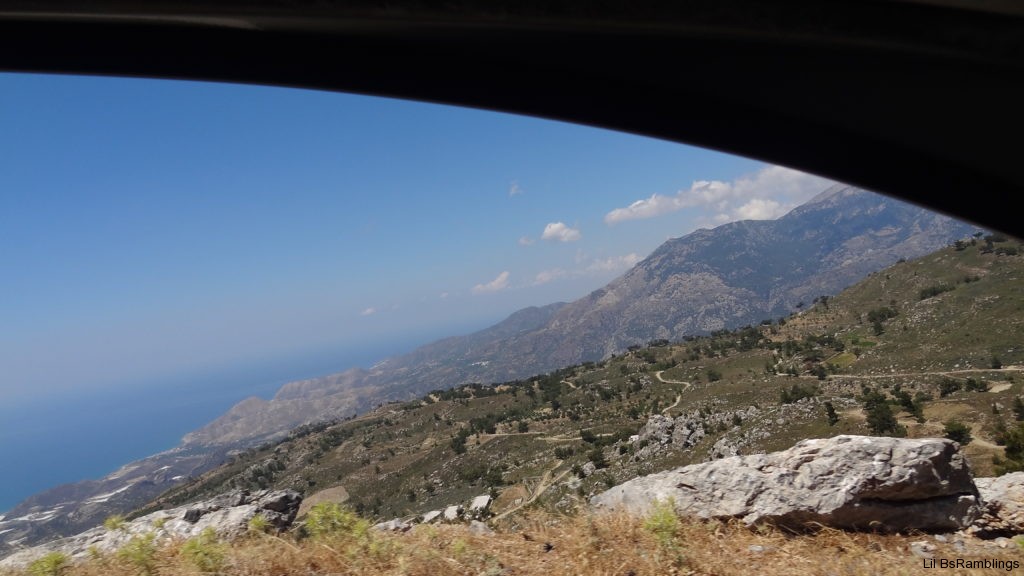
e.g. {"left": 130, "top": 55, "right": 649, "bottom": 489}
{"left": 0, "top": 332, "right": 444, "bottom": 516}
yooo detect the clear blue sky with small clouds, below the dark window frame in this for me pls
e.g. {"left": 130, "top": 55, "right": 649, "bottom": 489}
{"left": 0, "top": 74, "right": 829, "bottom": 407}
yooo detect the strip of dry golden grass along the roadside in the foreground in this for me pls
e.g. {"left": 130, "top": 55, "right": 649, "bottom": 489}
{"left": 4, "top": 513, "right": 1024, "bottom": 576}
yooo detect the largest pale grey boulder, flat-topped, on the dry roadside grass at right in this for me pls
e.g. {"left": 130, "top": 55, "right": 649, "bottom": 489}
{"left": 591, "top": 436, "right": 982, "bottom": 531}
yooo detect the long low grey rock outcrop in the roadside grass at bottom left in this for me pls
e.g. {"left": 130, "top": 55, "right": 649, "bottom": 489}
{"left": 0, "top": 490, "right": 302, "bottom": 569}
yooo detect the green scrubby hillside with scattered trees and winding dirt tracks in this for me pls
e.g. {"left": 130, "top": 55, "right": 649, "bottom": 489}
{"left": 138, "top": 239, "right": 1024, "bottom": 519}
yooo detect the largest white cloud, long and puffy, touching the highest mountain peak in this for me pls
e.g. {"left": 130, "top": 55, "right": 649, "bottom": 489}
{"left": 604, "top": 166, "right": 834, "bottom": 224}
